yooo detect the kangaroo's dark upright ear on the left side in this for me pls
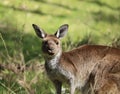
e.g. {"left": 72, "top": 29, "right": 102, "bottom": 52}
{"left": 32, "top": 24, "right": 47, "bottom": 38}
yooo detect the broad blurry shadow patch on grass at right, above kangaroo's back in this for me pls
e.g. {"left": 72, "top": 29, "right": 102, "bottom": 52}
{"left": 92, "top": 11, "right": 120, "bottom": 24}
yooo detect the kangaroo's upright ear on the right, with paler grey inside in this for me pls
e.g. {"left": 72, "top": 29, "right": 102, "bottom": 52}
{"left": 55, "top": 24, "right": 69, "bottom": 38}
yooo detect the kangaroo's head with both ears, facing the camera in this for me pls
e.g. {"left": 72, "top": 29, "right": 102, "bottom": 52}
{"left": 33, "top": 24, "right": 68, "bottom": 57}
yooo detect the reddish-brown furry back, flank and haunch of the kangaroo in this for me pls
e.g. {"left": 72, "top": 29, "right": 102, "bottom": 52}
{"left": 60, "top": 45, "right": 120, "bottom": 94}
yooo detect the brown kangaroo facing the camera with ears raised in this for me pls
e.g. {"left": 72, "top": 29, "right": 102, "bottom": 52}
{"left": 32, "top": 24, "right": 120, "bottom": 94}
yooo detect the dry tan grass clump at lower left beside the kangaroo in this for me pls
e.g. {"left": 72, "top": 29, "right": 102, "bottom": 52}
{"left": 0, "top": 53, "right": 44, "bottom": 94}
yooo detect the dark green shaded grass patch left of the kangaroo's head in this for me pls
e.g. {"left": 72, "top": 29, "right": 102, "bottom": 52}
{"left": 0, "top": 28, "right": 41, "bottom": 61}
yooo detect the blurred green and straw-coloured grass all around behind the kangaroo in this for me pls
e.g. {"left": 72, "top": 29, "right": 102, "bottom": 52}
{"left": 0, "top": 0, "right": 120, "bottom": 94}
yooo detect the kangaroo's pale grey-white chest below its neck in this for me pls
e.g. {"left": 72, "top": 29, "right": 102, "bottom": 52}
{"left": 45, "top": 60, "right": 71, "bottom": 81}
